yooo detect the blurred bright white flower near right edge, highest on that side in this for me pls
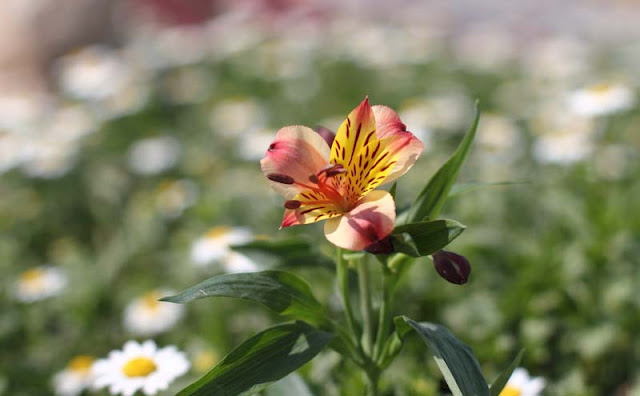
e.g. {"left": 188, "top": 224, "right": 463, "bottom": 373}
{"left": 568, "top": 84, "right": 636, "bottom": 117}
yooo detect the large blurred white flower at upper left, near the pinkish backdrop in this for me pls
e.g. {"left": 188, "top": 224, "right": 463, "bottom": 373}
{"left": 56, "top": 45, "right": 130, "bottom": 100}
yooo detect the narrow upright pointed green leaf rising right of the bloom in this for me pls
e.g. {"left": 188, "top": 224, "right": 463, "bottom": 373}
{"left": 405, "top": 102, "right": 480, "bottom": 223}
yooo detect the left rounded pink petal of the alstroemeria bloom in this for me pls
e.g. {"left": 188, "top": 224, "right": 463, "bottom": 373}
{"left": 260, "top": 125, "right": 329, "bottom": 198}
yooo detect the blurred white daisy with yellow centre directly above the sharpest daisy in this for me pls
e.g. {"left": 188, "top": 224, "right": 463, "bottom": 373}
{"left": 124, "top": 290, "right": 184, "bottom": 335}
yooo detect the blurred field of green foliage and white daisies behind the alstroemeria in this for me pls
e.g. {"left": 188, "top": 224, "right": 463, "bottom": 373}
{"left": 0, "top": 0, "right": 640, "bottom": 396}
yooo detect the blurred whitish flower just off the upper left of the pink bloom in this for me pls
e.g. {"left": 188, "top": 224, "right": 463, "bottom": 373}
{"left": 209, "top": 98, "right": 266, "bottom": 137}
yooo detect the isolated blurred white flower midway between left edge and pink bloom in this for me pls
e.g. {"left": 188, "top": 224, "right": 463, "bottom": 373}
{"left": 128, "top": 136, "right": 180, "bottom": 175}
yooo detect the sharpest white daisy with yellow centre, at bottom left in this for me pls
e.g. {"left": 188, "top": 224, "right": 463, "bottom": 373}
{"left": 92, "top": 340, "right": 190, "bottom": 396}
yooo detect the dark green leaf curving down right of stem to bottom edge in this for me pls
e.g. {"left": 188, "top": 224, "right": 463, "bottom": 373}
{"left": 394, "top": 316, "right": 490, "bottom": 396}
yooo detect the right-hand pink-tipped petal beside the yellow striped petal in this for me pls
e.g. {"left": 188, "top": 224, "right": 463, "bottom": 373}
{"left": 372, "top": 105, "right": 424, "bottom": 184}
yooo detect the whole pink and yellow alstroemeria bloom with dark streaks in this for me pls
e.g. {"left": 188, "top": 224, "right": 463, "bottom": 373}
{"left": 260, "top": 98, "right": 423, "bottom": 250}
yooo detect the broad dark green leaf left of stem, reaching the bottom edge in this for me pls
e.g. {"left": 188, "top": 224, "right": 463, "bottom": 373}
{"left": 178, "top": 322, "right": 333, "bottom": 396}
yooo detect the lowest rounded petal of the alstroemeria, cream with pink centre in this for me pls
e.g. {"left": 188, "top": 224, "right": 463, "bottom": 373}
{"left": 324, "top": 190, "right": 396, "bottom": 250}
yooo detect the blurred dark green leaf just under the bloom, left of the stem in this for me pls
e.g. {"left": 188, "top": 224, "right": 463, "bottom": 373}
{"left": 231, "top": 238, "right": 334, "bottom": 268}
